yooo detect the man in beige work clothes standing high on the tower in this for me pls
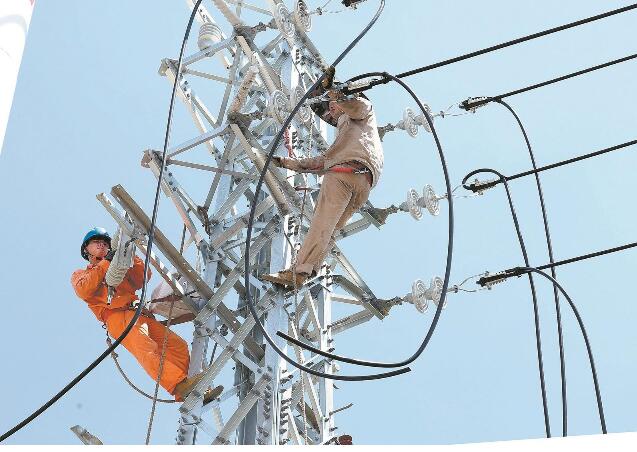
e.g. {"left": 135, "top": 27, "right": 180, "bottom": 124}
{"left": 262, "top": 85, "right": 383, "bottom": 286}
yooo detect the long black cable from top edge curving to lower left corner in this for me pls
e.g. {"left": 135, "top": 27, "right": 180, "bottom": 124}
{"left": 0, "top": 0, "right": 202, "bottom": 442}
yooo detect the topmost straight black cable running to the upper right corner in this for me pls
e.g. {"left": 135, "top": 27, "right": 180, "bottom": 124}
{"left": 350, "top": 3, "right": 637, "bottom": 93}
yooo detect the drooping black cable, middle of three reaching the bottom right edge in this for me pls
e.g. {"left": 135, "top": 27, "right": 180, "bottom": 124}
{"left": 495, "top": 99, "right": 568, "bottom": 436}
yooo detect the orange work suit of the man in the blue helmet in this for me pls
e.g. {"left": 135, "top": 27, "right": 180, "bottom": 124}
{"left": 71, "top": 256, "right": 190, "bottom": 394}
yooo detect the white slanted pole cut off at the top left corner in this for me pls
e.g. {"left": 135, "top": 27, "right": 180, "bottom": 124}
{"left": 0, "top": 0, "right": 35, "bottom": 152}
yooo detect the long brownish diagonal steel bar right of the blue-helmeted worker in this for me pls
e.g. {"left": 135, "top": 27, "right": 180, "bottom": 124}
{"left": 111, "top": 185, "right": 264, "bottom": 359}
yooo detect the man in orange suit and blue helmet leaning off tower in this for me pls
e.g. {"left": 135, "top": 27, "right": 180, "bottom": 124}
{"left": 71, "top": 227, "right": 223, "bottom": 403}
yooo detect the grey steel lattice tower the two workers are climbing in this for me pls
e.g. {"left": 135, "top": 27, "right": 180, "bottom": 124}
{"left": 98, "top": 0, "right": 440, "bottom": 444}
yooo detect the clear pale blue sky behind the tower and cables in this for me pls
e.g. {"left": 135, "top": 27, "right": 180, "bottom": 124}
{"left": 0, "top": 0, "right": 637, "bottom": 444}
